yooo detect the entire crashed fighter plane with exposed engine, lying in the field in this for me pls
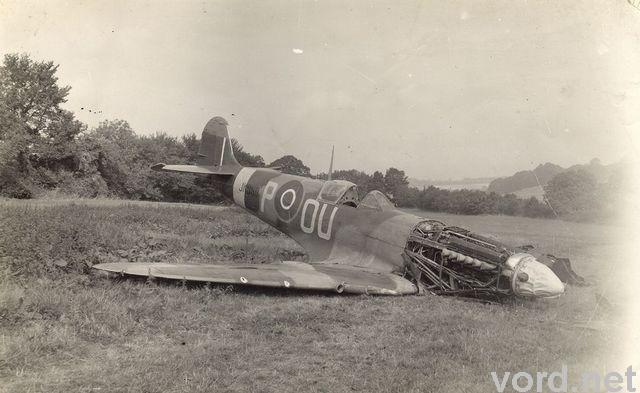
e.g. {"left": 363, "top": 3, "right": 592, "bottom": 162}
{"left": 94, "top": 117, "right": 564, "bottom": 298}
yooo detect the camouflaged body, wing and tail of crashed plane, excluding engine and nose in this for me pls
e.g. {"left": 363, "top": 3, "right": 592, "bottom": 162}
{"left": 94, "top": 117, "right": 424, "bottom": 295}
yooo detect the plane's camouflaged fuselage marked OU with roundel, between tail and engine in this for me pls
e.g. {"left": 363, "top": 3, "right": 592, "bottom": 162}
{"left": 218, "top": 168, "right": 424, "bottom": 272}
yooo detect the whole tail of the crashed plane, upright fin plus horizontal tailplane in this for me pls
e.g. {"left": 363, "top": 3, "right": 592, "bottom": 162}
{"left": 151, "top": 117, "right": 242, "bottom": 175}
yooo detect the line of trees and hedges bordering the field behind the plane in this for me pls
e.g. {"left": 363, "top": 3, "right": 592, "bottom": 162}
{"left": 0, "top": 54, "right": 632, "bottom": 219}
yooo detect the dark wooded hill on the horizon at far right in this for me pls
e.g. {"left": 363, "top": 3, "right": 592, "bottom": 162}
{"left": 487, "top": 158, "right": 619, "bottom": 197}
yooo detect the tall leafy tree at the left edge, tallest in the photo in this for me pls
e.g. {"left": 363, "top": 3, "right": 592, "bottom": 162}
{"left": 0, "top": 54, "right": 85, "bottom": 197}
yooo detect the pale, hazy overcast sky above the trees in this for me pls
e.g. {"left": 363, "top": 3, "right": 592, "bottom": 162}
{"left": 0, "top": 0, "right": 640, "bottom": 179}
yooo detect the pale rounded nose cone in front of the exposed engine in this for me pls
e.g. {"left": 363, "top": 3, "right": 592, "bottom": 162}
{"left": 511, "top": 256, "right": 564, "bottom": 298}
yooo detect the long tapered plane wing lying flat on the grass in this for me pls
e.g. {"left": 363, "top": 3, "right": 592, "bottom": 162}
{"left": 93, "top": 262, "right": 417, "bottom": 295}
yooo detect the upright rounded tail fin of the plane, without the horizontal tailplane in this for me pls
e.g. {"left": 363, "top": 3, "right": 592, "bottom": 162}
{"left": 198, "top": 117, "right": 240, "bottom": 167}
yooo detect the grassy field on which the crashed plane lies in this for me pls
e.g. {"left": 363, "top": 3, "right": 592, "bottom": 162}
{"left": 0, "top": 200, "right": 631, "bottom": 392}
